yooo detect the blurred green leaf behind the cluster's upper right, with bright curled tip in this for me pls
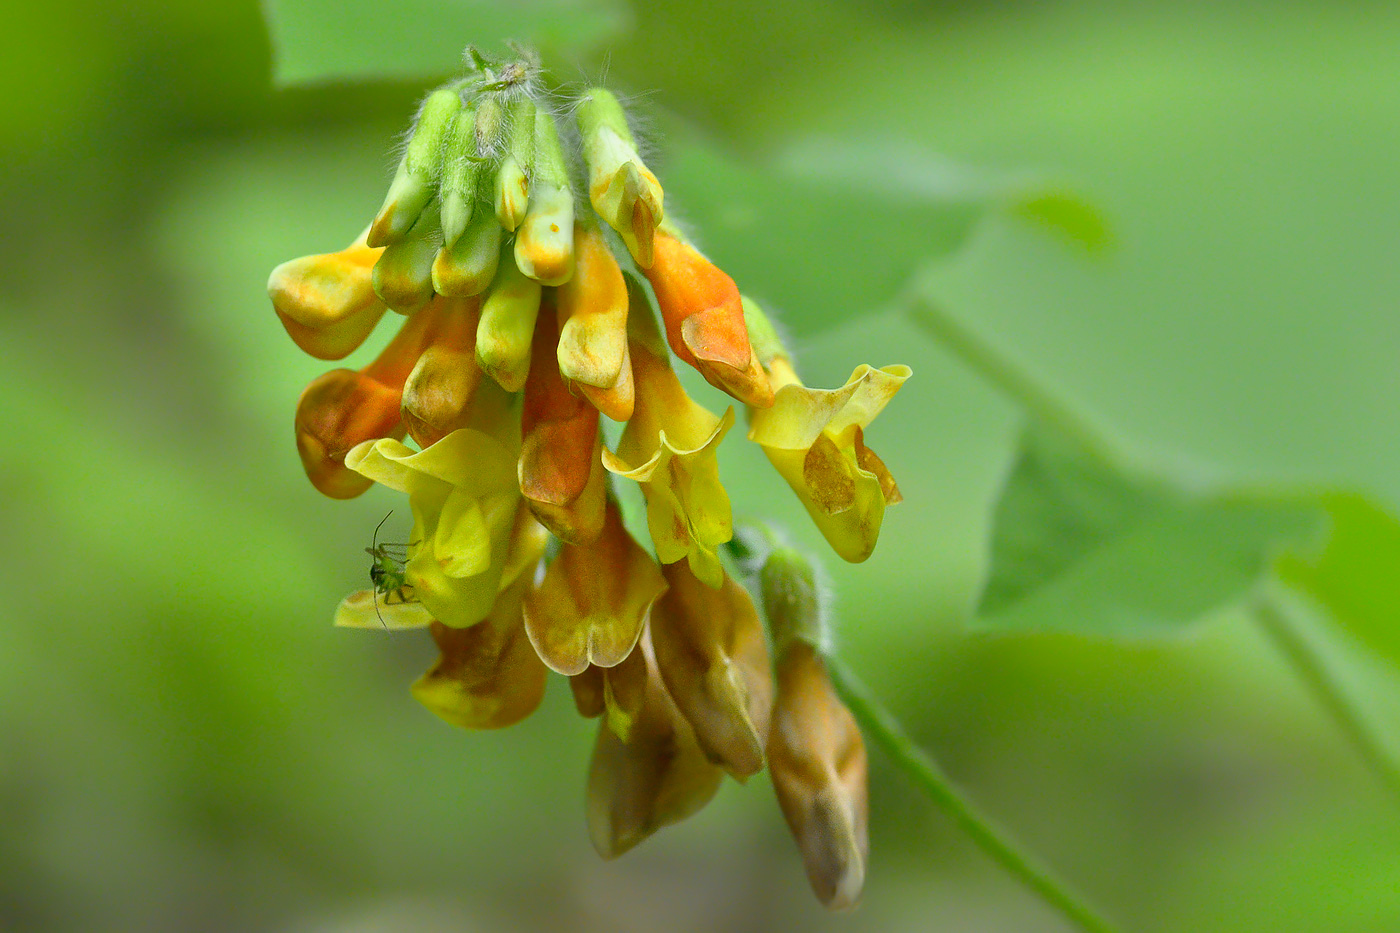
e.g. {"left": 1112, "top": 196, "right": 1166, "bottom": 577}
{"left": 662, "top": 136, "right": 1107, "bottom": 336}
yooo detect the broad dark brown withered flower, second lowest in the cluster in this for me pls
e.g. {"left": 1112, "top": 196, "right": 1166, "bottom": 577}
{"left": 588, "top": 637, "right": 724, "bottom": 859}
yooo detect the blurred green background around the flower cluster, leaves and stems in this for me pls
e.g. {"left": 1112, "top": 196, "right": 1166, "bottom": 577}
{"left": 0, "top": 0, "right": 1400, "bottom": 933}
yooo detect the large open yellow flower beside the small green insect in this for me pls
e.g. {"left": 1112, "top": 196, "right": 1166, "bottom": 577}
{"left": 346, "top": 427, "right": 519, "bottom": 628}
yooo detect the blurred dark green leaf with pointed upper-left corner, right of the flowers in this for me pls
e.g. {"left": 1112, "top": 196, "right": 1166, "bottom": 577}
{"left": 974, "top": 424, "right": 1320, "bottom": 637}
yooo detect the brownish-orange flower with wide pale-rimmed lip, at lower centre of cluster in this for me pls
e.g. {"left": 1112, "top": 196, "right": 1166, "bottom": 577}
{"left": 525, "top": 502, "right": 666, "bottom": 677}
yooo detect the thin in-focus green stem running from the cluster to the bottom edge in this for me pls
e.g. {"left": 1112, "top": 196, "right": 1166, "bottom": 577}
{"left": 826, "top": 657, "right": 1114, "bottom": 933}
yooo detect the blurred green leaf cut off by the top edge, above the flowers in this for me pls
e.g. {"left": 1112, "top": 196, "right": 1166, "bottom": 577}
{"left": 263, "top": 0, "right": 629, "bottom": 85}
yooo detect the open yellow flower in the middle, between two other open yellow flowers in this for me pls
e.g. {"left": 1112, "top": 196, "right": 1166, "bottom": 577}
{"left": 603, "top": 334, "right": 734, "bottom": 587}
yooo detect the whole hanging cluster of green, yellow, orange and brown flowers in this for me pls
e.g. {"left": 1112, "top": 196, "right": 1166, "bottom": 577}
{"left": 269, "top": 52, "right": 909, "bottom": 906}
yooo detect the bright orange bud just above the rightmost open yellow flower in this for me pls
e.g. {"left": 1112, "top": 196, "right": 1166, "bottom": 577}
{"left": 646, "top": 231, "right": 773, "bottom": 408}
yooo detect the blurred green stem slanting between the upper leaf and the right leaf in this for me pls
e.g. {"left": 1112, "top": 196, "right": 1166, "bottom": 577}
{"left": 907, "top": 293, "right": 1124, "bottom": 464}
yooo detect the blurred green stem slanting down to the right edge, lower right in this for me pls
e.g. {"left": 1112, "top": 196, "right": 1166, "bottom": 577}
{"left": 1254, "top": 587, "right": 1400, "bottom": 799}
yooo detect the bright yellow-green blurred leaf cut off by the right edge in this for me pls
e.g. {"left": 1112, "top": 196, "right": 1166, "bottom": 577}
{"left": 1277, "top": 492, "right": 1400, "bottom": 665}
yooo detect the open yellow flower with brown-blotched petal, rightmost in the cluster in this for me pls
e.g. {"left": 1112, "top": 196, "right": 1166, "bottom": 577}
{"left": 749, "top": 357, "right": 910, "bottom": 563}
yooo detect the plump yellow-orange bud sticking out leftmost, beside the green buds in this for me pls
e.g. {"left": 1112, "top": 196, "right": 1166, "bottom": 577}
{"left": 267, "top": 232, "right": 384, "bottom": 360}
